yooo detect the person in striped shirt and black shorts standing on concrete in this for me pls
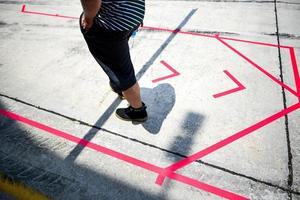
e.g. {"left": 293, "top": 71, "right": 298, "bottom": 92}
{"left": 79, "top": 0, "right": 148, "bottom": 122}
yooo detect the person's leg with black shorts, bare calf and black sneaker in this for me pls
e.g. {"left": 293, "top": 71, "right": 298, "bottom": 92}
{"left": 81, "top": 16, "right": 147, "bottom": 122}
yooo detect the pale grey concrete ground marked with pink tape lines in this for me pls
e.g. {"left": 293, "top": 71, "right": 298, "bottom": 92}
{"left": 0, "top": 0, "right": 300, "bottom": 200}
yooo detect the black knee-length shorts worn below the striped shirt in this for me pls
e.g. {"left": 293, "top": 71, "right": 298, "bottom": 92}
{"left": 79, "top": 14, "right": 136, "bottom": 92}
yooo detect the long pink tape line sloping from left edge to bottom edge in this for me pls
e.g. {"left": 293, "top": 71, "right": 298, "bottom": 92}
{"left": 0, "top": 109, "right": 248, "bottom": 200}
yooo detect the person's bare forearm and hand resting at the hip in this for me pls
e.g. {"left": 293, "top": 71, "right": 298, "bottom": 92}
{"left": 81, "top": 0, "right": 101, "bottom": 30}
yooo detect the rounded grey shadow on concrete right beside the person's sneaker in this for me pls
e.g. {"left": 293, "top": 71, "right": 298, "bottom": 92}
{"left": 141, "top": 83, "right": 176, "bottom": 134}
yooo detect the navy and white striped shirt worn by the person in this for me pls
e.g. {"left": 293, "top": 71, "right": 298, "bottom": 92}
{"left": 97, "top": 0, "right": 145, "bottom": 31}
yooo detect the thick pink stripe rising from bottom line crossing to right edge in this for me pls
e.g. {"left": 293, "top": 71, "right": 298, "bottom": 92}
{"left": 156, "top": 103, "right": 300, "bottom": 185}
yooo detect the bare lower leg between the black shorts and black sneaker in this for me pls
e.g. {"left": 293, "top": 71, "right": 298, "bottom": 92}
{"left": 123, "top": 82, "right": 143, "bottom": 108}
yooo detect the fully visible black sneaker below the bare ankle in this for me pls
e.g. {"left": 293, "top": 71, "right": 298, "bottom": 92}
{"left": 116, "top": 103, "right": 148, "bottom": 122}
